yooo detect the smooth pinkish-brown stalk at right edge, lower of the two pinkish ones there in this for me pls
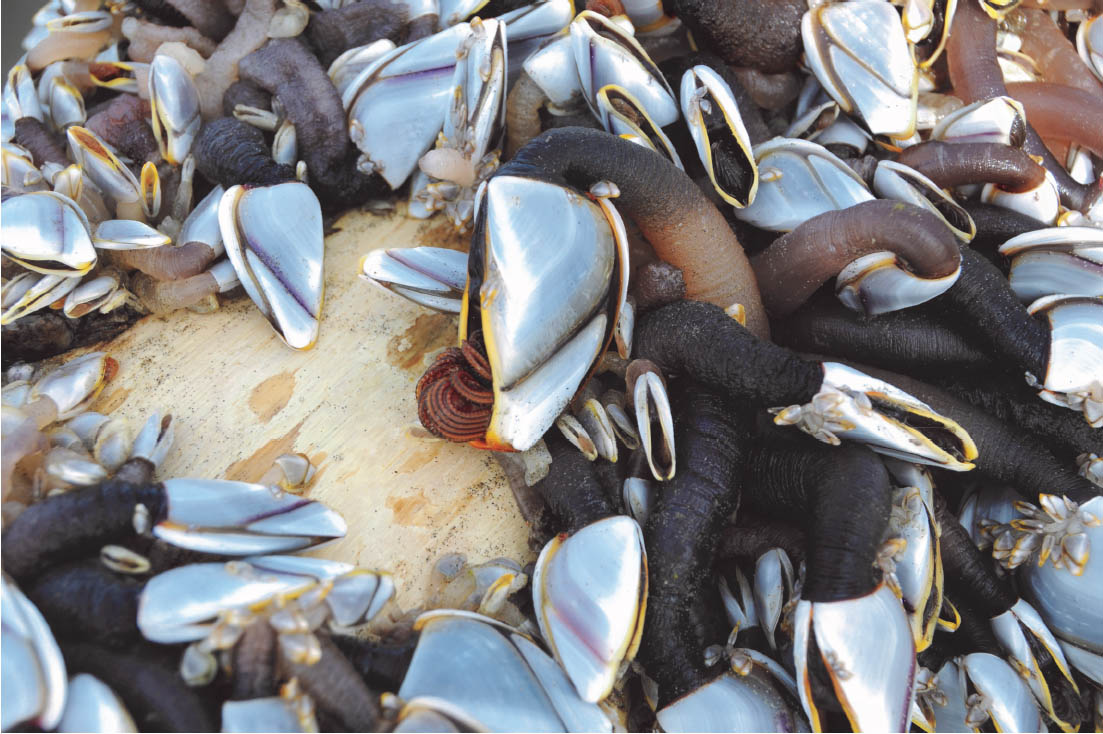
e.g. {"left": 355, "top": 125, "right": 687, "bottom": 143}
{"left": 1007, "top": 82, "right": 1103, "bottom": 156}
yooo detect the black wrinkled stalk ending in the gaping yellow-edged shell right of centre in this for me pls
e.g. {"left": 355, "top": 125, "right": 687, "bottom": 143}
{"left": 632, "top": 300, "right": 823, "bottom": 407}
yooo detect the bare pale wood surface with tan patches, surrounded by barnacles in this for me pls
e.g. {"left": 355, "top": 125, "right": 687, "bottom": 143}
{"left": 78, "top": 206, "right": 533, "bottom": 609}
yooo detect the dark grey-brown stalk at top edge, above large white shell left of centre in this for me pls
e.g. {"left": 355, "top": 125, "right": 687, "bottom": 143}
{"left": 306, "top": 0, "right": 409, "bottom": 67}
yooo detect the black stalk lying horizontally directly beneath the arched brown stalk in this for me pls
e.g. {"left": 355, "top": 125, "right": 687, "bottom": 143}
{"left": 772, "top": 294, "right": 997, "bottom": 375}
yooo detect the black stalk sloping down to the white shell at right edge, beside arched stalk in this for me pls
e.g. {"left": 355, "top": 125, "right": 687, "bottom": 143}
{"left": 919, "top": 247, "right": 1049, "bottom": 380}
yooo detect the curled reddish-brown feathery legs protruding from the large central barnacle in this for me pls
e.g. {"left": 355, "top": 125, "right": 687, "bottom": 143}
{"left": 415, "top": 332, "right": 494, "bottom": 443}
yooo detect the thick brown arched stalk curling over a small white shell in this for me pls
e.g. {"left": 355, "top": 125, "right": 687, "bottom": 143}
{"left": 751, "top": 200, "right": 960, "bottom": 316}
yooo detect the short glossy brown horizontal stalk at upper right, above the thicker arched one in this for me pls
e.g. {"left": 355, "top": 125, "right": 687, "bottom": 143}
{"left": 897, "top": 140, "right": 1046, "bottom": 192}
